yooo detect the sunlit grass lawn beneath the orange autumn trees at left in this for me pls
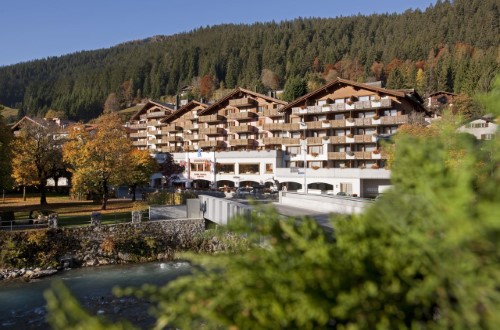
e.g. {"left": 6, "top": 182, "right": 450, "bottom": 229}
{"left": 0, "top": 194, "right": 146, "bottom": 226}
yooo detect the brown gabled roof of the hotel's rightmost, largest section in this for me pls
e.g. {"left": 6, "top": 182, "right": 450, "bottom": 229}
{"left": 278, "top": 78, "right": 423, "bottom": 112}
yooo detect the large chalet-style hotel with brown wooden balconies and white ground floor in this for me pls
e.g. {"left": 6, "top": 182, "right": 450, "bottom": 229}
{"left": 131, "top": 79, "right": 425, "bottom": 197}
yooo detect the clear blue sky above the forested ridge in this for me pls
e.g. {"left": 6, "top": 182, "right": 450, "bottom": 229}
{"left": 0, "top": 0, "right": 435, "bottom": 66}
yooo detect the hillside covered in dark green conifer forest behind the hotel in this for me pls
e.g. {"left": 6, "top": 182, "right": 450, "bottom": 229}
{"left": 0, "top": 0, "right": 500, "bottom": 120}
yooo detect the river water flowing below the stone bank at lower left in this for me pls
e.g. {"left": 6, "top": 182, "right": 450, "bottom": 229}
{"left": 0, "top": 262, "right": 191, "bottom": 329}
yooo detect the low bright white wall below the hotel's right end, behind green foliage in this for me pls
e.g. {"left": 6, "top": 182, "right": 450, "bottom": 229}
{"left": 279, "top": 191, "right": 373, "bottom": 214}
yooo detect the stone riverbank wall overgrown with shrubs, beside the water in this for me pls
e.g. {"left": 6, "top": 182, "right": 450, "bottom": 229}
{"left": 0, "top": 219, "right": 205, "bottom": 276}
